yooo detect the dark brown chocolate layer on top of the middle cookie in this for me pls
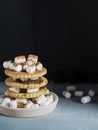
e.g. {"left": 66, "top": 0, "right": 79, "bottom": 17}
{"left": 16, "top": 77, "right": 43, "bottom": 84}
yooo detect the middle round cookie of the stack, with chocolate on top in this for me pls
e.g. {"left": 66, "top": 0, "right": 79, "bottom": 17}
{"left": 5, "top": 77, "right": 48, "bottom": 89}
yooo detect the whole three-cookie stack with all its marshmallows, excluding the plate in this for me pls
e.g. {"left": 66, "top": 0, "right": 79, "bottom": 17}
{"left": 1, "top": 54, "right": 54, "bottom": 109}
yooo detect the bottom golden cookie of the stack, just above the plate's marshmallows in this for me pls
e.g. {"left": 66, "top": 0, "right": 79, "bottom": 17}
{"left": 7, "top": 87, "right": 49, "bottom": 99}
